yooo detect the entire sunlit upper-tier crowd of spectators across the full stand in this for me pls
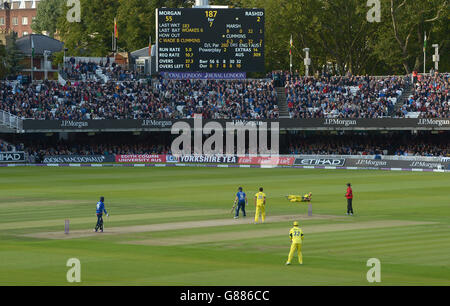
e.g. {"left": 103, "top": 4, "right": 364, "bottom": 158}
{"left": 0, "top": 67, "right": 450, "bottom": 120}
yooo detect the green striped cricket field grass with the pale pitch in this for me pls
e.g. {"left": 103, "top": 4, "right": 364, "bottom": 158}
{"left": 0, "top": 167, "right": 450, "bottom": 286}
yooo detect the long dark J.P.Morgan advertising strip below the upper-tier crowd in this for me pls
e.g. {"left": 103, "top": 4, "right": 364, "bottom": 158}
{"left": 23, "top": 119, "right": 450, "bottom": 133}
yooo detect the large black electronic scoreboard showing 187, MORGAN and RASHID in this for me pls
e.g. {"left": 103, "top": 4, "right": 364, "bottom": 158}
{"left": 156, "top": 8, "right": 265, "bottom": 72}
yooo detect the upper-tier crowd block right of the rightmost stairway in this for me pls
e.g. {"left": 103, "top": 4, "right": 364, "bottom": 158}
{"left": 397, "top": 73, "right": 450, "bottom": 118}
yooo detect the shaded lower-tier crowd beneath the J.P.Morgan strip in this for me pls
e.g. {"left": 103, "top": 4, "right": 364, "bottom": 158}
{"left": 0, "top": 132, "right": 450, "bottom": 157}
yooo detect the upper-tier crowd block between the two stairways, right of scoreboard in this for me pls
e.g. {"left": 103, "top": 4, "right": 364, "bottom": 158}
{"left": 285, "top": 75, "right": 405, "bottom": 118}
